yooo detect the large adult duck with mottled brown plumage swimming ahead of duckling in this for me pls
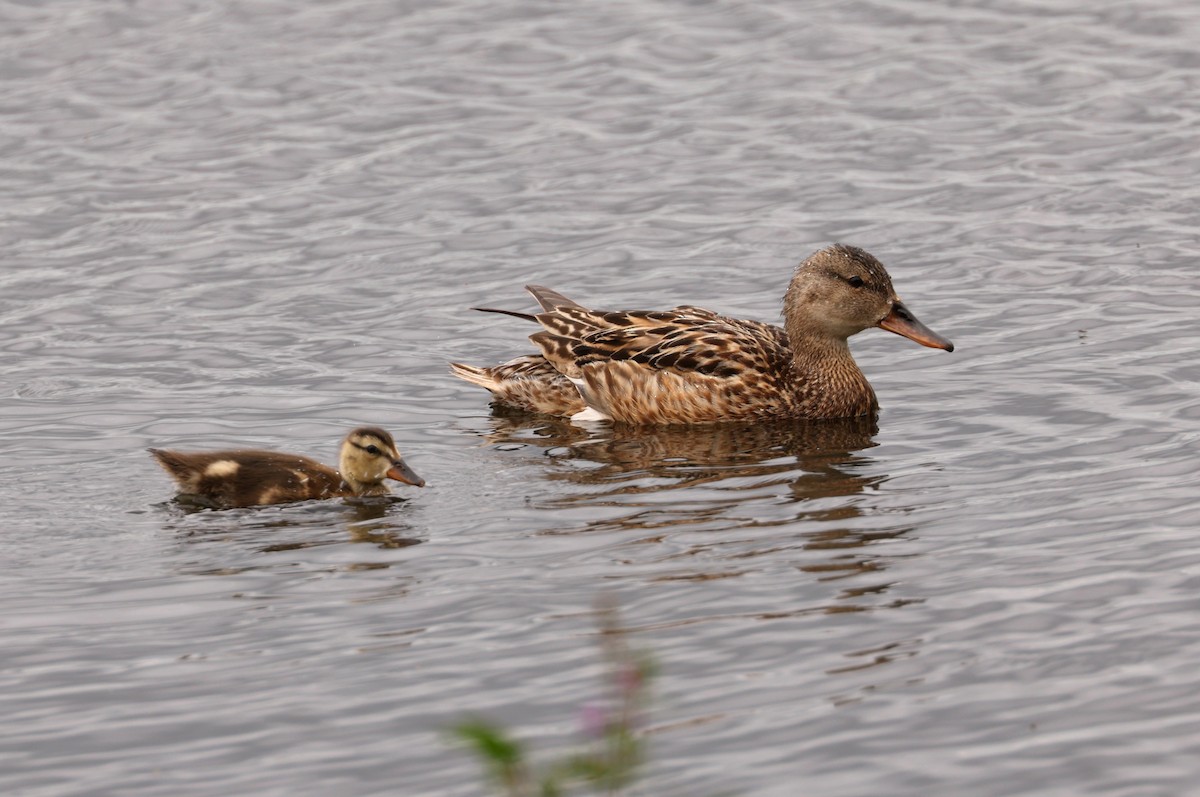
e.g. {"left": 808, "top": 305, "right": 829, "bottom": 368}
{"left": 450, "top": 244, "right": 954, "bottom": 425}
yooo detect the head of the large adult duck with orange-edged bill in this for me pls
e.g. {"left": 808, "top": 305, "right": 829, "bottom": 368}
{"left": 784, "top": 244, "right": 954, "bottom": 352}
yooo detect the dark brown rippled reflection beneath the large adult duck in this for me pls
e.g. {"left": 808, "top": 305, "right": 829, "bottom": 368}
{"left": 472, "top": 411, "right": 911, "bottom": 611}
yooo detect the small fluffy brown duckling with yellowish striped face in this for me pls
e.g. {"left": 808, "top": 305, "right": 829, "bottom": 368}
{"left": 149, "top": 426, "right": 425, "bottom": 508}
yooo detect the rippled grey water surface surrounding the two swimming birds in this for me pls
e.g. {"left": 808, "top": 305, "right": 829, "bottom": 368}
{"left": 0, "top": 0, "right": 1200, "bottom": 797}
